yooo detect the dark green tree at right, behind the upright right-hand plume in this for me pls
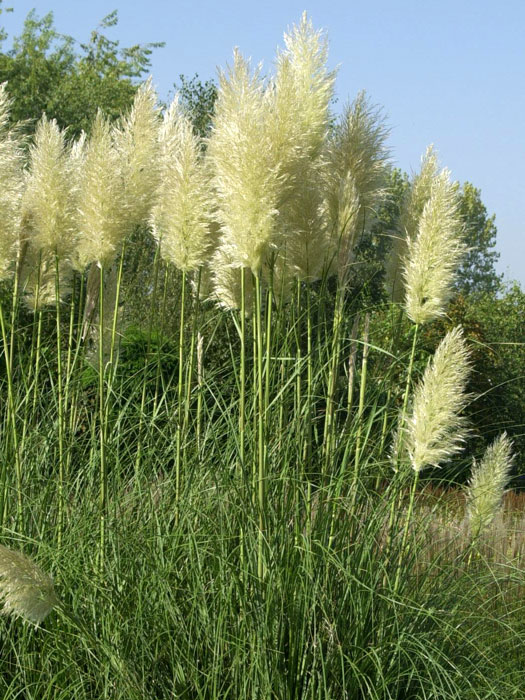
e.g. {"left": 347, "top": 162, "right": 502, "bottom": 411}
{"left": 456, "top": 182, "right": 502, "bottom": 294}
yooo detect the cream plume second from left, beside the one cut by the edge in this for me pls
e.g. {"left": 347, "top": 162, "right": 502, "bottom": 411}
{"left": 22, "top": 115, "right": 75, "bottom": 258}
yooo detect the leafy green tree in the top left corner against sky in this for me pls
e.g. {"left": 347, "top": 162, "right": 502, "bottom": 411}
{"left": 0, "top": 10, "right": 162, "bottom": 136}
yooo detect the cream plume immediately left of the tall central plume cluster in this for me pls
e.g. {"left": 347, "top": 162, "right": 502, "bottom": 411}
{"left": 151, "top": 99, "right": 211, "bottom": 271}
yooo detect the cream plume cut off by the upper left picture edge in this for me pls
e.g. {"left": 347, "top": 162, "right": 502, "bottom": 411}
{"left": 0, "top": 83, "right": 24, "bottom": 280}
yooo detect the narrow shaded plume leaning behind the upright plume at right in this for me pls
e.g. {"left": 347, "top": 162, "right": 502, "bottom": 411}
{"left": 386, "top": 146, "right": 439, "bottom": 303}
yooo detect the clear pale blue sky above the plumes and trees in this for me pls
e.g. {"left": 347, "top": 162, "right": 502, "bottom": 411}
{"left": 0, "top": 0, "right": 525, "bottom": 286}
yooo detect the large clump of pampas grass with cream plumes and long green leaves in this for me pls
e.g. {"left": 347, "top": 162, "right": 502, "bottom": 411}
{"left": 0, "top": 16, "right": 525, "bottom": 700}
